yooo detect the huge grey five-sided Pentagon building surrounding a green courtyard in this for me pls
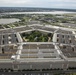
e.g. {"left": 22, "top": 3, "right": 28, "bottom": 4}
{"left": 0, "top": 25, "right": 76, "bottom": 70}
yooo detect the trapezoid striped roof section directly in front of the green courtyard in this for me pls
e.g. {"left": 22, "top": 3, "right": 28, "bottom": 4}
{"left": 20, "top": 43, "right": 61, "bottom": 62}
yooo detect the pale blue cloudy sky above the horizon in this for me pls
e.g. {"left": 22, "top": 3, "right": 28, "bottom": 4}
{"left": 0, "top": 0, "right": 76, "bottom": 9}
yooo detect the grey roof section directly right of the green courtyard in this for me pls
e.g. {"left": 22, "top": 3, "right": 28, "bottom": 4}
{"left": 57, "top": 34, "right": 76, "bottom": 45}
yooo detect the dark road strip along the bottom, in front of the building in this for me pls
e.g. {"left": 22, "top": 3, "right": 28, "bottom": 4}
{"left": 0, "top": 70, "right": 76, "bottom": 75}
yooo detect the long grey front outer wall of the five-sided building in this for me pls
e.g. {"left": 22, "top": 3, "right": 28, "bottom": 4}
{"left": 0, "top": 62, "right": 76, "bottom": 70}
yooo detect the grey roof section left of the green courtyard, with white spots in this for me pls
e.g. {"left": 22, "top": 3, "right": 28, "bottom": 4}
{"left": 0, "top": 33, "right": 19, "bottom": 45}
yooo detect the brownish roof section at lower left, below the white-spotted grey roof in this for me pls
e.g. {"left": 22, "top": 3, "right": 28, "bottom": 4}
{"left": 0, "top": 45, "right": 17, "bottom": 59}
